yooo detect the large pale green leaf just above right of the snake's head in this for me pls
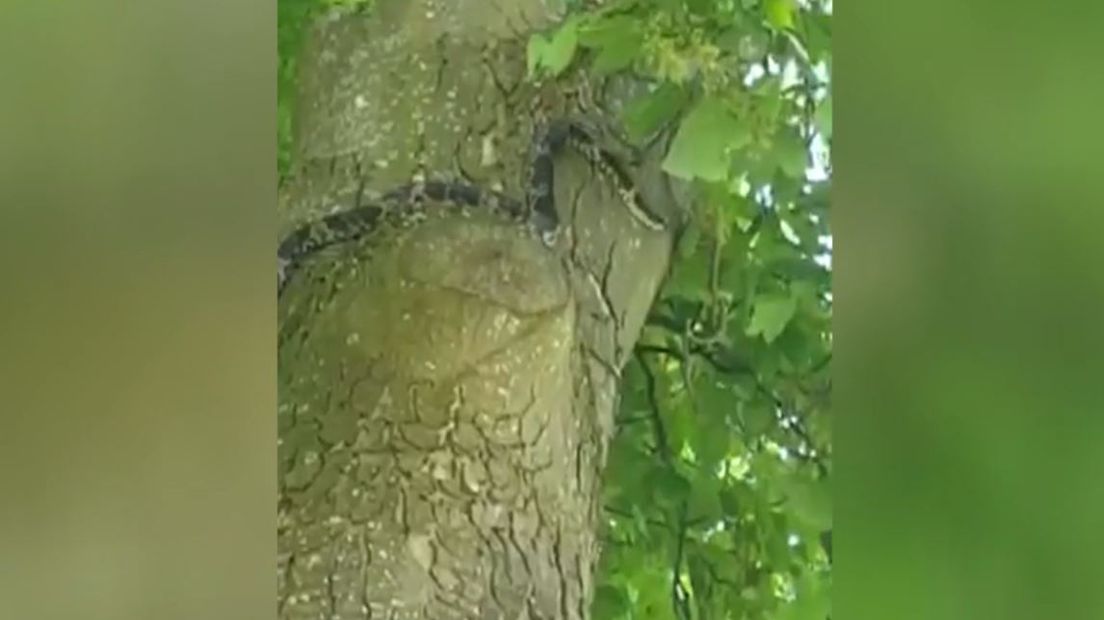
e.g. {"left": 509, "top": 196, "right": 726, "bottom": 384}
{"left": 664, "top": 97, "right": 751, "bottom": 181}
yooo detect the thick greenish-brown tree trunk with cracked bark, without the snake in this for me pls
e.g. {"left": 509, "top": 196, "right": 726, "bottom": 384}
{"left": 277, "top": 0, "right": 677, "bottom": 620}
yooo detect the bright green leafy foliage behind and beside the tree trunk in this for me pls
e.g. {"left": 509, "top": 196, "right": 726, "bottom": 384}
{"left": 279, "top": 0, "right": 832, "bottom": 620}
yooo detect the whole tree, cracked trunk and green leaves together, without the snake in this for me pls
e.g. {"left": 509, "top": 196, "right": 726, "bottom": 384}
{"left": 277, "top": 0, "right": 830, "bottom": 619}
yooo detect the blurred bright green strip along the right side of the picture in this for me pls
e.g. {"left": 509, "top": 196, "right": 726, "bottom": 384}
{"left": 832, "top": 1, "right": 1104, "bottom": 620}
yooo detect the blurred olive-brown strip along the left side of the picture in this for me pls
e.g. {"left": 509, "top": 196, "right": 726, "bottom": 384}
{"left": 0, "top": 1, "right": 276, "bottom": 619}
